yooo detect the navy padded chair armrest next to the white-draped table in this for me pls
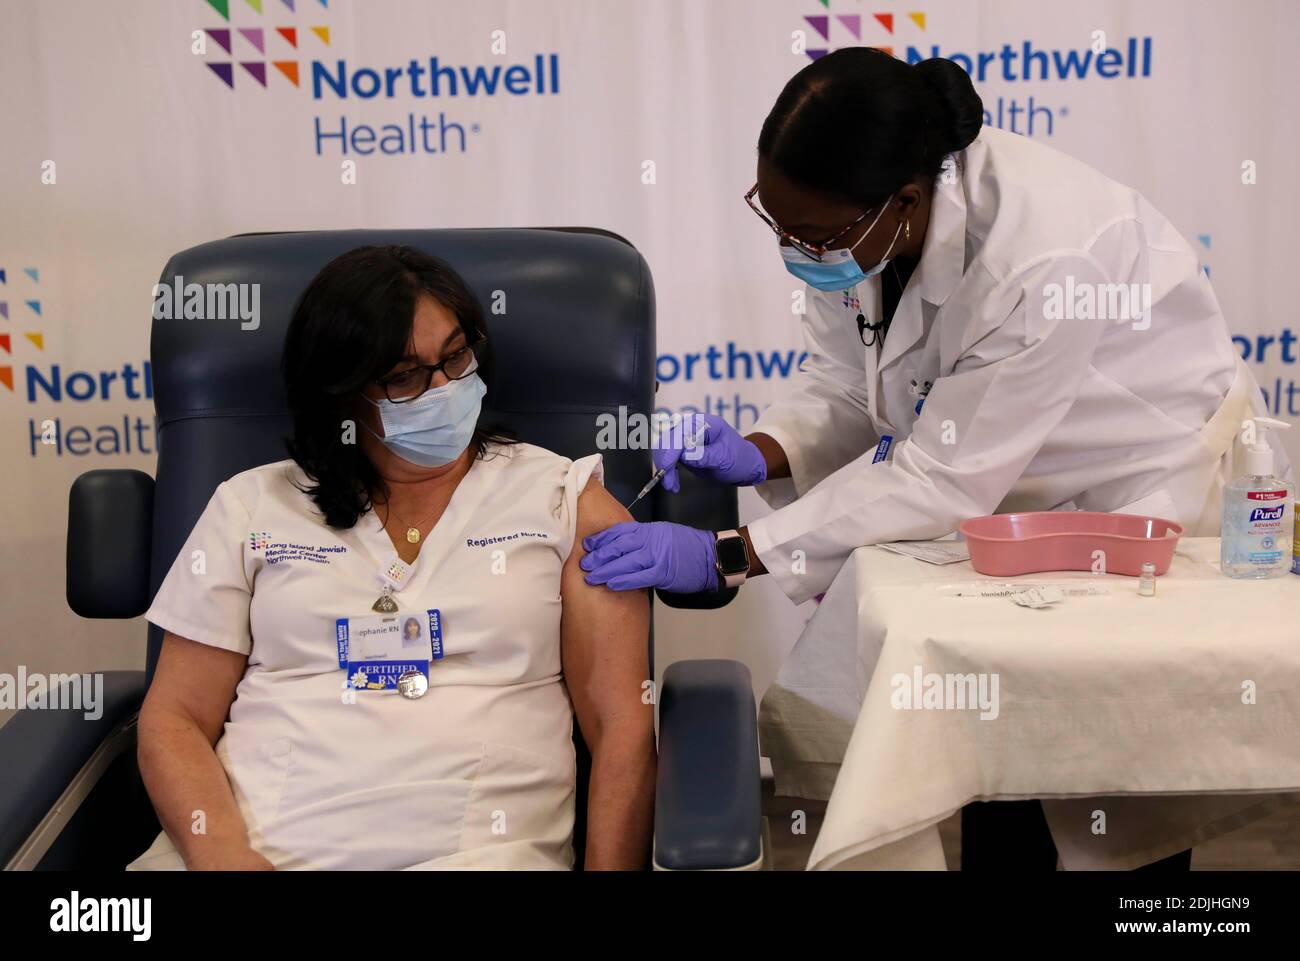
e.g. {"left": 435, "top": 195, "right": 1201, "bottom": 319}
{"left": 654, "top": 661, "right": 763, "bottom": 871}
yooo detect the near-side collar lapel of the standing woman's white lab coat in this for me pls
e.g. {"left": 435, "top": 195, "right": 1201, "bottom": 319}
{"left": 878, "top": 156, "right": 966, "bottom": 369}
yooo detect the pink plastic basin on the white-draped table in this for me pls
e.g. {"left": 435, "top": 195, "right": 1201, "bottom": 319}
{"left": 957, "top": 511, "right": 1184, "bottom": 577}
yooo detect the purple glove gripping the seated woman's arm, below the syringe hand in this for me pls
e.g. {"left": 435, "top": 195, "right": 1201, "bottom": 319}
{"left": 579, "top": 520, "right": 718, "bottom": 594}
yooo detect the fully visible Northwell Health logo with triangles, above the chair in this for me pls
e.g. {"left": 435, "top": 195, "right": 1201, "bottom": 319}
{"left": 191, "top": 0, "right": 560, "bottom": 159}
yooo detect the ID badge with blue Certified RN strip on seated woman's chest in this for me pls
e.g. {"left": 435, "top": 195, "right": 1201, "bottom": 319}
{"left": 334, "top": 609, "right": 443, "bottom": 696}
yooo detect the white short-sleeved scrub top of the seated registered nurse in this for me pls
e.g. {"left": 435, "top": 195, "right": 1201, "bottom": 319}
{"left": 131, "top": 443, "right": 602, "bottom": 870}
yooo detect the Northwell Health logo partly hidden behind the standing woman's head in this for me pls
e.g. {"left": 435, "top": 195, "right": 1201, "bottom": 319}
{"left": 796, "top": 0, "right": 1153, "bottom": 138}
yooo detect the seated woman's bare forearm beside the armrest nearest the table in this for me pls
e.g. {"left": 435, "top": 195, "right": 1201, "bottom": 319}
{"left": 584, "top": 717, "right": 657, "bottom": 871}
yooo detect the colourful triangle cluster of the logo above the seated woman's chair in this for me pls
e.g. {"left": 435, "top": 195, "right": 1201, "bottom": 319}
{"left": 203, "top": 0, "right": 332, "bottom": 90}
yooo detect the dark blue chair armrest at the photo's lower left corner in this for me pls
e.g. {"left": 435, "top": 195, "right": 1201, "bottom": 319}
{"left": 0, "top": 671, "right": 144, "bottom": 866}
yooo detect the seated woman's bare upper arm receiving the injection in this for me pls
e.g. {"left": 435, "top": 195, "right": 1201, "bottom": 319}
{"left": 560, "top": 477, "right": 654, "bottom": 749}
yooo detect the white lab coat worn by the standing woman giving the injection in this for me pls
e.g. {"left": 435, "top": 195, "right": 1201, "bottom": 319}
{"left": 749, "top": 126, "right": 1290, "bottom": 603}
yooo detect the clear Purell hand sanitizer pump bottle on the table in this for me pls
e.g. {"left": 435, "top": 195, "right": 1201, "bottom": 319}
{"left": 1219, "top": 417, "right": 1295, "bottom": 579}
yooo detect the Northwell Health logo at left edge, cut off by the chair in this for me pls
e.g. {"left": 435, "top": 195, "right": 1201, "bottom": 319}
{"left": 0, "top": 264, "right": 157, "bottom": 458}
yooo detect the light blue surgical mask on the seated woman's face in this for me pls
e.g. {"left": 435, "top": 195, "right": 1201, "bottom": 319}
{"left": 363, "top": 373, "right": 488, "bottom": 467}
